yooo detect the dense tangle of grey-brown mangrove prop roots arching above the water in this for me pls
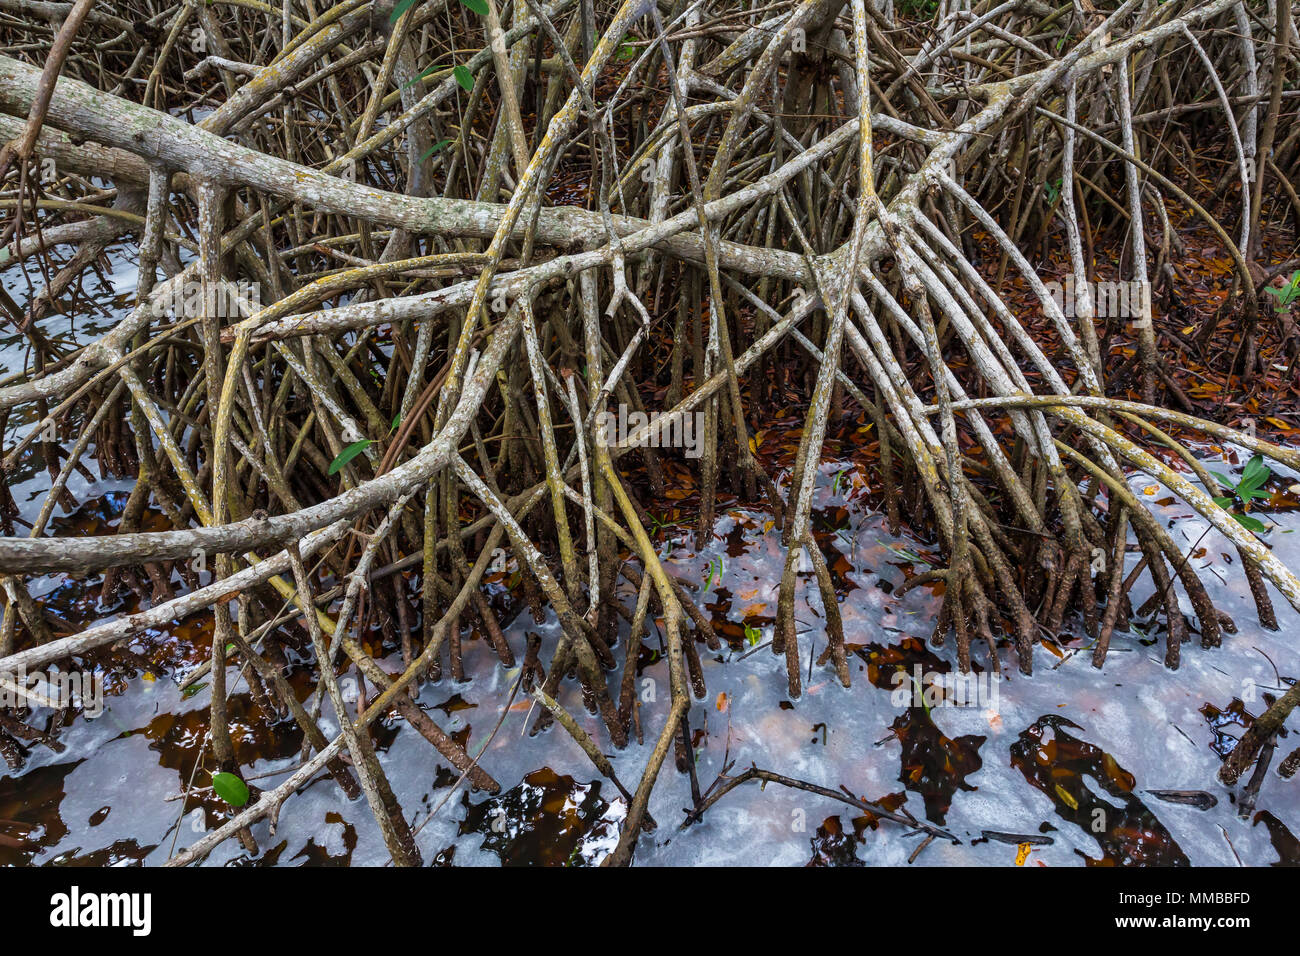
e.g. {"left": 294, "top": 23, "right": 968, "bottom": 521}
{"left": 0, "top": 0, "right": 1300, "bottom": 864}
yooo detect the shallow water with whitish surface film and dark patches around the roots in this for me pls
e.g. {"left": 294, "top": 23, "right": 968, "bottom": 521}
{"left": 0, "top": 240, "right": 1300, "bottom": 866}
